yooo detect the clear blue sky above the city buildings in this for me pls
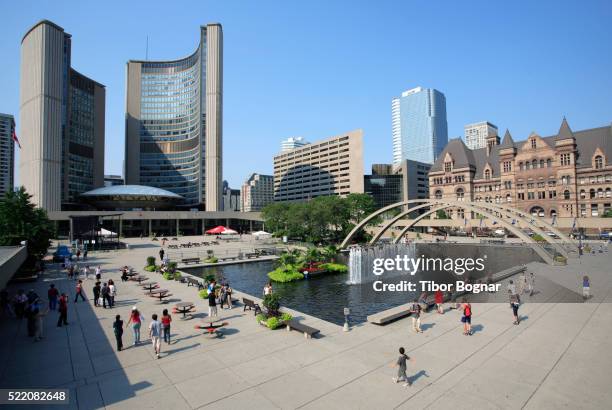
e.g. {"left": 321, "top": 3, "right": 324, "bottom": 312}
{"left": 0, "top": 0, "right": 612, "bottom": 187}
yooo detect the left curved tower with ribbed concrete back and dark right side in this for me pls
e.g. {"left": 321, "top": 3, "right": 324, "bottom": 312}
{"left": 19, "top": 20, "right": 106, "bottom": 211}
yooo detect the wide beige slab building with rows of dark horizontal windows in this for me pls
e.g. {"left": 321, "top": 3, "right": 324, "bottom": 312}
{"left": 274, "top": 130, "right": 363, "bottom": 201}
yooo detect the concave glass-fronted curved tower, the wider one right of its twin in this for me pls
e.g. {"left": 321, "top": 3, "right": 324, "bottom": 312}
{"left": 125, "top": 24, "right": 223, "bottom": 211}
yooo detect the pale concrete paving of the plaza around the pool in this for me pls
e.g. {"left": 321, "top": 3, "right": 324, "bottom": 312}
{"left": 0, "top": 238, "right": 612, "bottom": 410}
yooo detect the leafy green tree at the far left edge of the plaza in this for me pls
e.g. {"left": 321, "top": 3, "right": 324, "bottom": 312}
{"left": 0, "top": 187, "right": 55, "bottom": 266}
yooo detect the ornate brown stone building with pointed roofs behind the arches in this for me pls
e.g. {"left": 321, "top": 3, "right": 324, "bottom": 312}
{"left": 429, "top": 119, "right": 612, "bottom": 218}
